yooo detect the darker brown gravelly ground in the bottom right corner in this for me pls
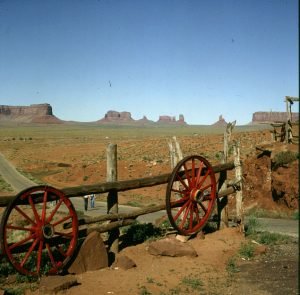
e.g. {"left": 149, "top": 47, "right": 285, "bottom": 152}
{"left": 227, "top": 240, "right": 299, "bottom": 295}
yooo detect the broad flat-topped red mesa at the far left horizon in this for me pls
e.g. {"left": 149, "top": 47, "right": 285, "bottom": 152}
{"left": 0, "top": 103, "right": 61, "bottom": 123}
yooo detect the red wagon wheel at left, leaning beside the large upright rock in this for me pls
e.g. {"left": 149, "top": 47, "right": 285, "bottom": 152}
{"left": 0, "top": 186, "right": 78, "bottom": 276}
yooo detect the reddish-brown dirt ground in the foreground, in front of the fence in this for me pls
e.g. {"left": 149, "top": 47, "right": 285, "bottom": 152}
{"left": 2, "top": 228, "right": 299, "bottom": 295}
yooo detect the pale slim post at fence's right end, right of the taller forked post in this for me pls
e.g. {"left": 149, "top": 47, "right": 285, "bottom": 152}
{"left": 233, "top": 142, "right": 245, "bottom": 232}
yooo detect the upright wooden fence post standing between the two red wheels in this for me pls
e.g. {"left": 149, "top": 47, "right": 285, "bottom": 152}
{"left": 106, "top": 143, "right": 120, "bottom": 255}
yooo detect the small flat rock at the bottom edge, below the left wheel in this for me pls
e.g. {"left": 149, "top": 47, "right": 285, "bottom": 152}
{"left": 39, "top": 275, "right": 78, "bottom": 294}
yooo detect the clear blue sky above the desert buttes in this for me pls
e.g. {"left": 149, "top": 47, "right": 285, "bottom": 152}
{"left": 0, "top": 0, "right": 299, "bottom": 125}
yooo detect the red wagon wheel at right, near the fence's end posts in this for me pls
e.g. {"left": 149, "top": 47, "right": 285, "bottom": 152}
{"left": 166, "top": 156, "right": 216, "bottom": 235}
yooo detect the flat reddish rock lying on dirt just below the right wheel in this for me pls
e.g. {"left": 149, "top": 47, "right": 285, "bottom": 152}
{"left": 148, "top": 238, "right": 198, "bottom": 257}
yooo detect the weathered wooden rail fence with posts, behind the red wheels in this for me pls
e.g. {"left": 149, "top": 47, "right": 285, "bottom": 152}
{"left": 0, "top": 128, "right": 243, "bottom": 253}
